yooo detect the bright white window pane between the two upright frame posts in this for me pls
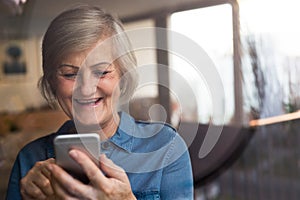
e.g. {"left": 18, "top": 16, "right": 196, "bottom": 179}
{"left": 169, "top": 4, "right": 234, "bottom": 124}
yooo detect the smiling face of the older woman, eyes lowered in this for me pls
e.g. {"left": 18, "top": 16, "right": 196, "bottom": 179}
{"left": 56, "top": 41, "right": 120, "bottom": 130}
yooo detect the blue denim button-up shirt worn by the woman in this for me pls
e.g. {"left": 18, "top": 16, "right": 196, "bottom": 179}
{"left": 6, "top": 112, "right": 193, "bottom": 200}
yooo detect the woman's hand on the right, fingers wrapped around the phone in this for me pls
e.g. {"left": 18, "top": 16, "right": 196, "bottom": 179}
{"left": 48, "top": 149, "right": 136, "bottom": 200}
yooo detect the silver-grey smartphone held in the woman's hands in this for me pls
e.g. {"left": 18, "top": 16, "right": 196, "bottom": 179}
{"left": 54, "top": 133, "right": 100, "bottom": 183}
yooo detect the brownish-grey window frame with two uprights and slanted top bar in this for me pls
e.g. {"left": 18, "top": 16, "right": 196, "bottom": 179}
{"left": 121, "top": 0, "right": 241, "bottom": 125}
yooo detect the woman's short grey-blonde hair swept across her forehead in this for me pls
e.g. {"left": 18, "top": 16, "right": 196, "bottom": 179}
{"left": 39, "top": 5, "right": 138, "bottom": 104}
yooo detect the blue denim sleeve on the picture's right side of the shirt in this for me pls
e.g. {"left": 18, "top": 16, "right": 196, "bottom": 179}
{"left": 161, "top": 135, "right": 194, "bottom": 200}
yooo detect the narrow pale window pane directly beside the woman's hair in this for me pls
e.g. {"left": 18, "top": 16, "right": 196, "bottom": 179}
{"left": 121, "top": 19, "right": 159, "bottom": 120}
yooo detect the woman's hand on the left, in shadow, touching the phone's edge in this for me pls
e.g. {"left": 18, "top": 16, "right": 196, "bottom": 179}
{"left": 20, "top": 158, "right": 55, "bottom": 200}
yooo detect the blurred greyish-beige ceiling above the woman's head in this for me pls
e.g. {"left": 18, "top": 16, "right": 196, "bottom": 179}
{"left": 0, "top": 0, "right": 217, "bottom": 39}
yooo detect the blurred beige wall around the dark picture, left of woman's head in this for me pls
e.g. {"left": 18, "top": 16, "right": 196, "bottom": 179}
{"left": 0, "top": 37, "right": 45, "bottom": 112}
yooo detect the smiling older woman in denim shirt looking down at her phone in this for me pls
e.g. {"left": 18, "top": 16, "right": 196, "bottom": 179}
{"left": 7, "top": 6, "right": 193, "bottom": 200}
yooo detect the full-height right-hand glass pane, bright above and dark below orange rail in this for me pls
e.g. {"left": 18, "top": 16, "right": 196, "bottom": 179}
{"left": 210, "top": 0, "right": 300, "bottom": 200}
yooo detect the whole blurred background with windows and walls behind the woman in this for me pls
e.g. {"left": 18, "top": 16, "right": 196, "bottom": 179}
{"left": 0, "top": 0, "right": 300, "bottom": 200}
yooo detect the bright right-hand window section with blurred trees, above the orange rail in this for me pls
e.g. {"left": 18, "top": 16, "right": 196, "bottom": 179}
{"left": 240, "top": 0, "right": 300, "bottom": 120}
